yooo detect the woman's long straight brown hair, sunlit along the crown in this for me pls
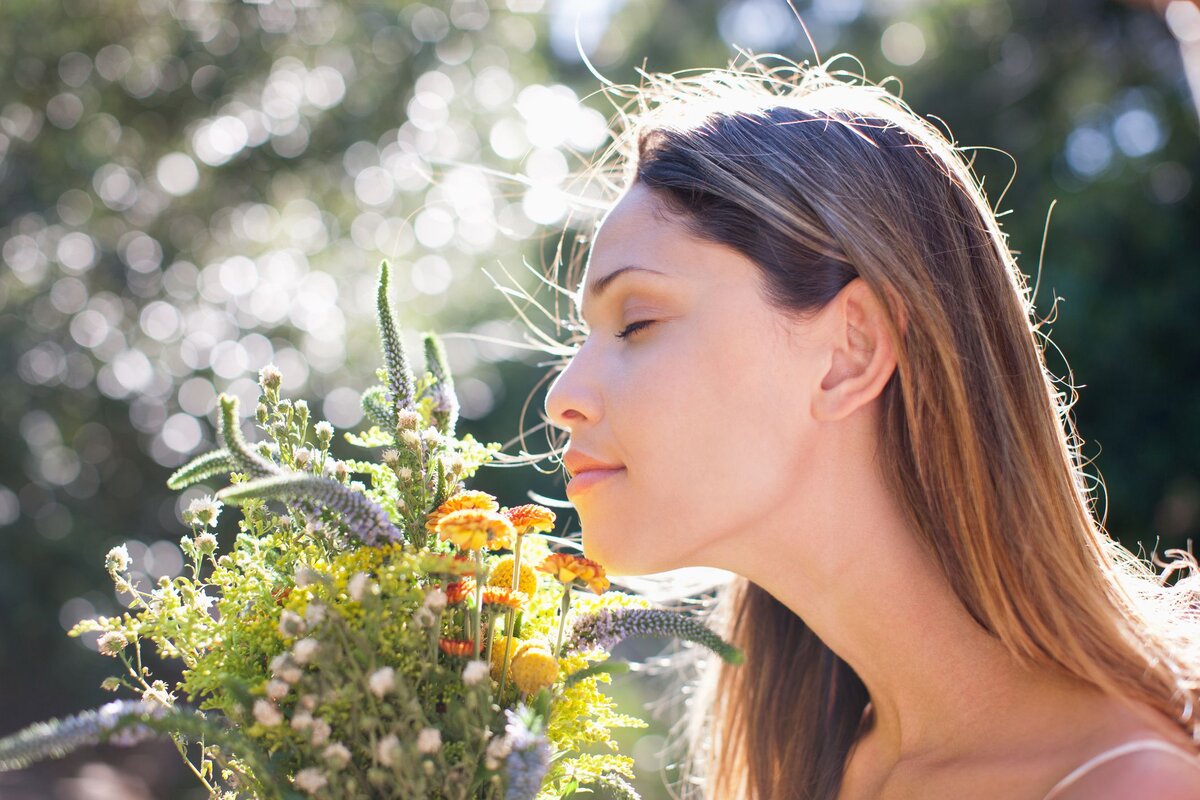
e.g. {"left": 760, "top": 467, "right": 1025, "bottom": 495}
{"left": 520, "top": 54, "right": 1200, "bottom": 800}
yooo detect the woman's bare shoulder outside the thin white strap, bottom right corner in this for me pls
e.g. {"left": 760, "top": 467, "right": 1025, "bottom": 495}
{"left": 1057, "top": 750, "right": 1200, "bottom": 800}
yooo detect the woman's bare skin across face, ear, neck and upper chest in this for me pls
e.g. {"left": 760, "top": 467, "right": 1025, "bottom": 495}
{"left": 546, "top": 184, "right": 1200, "bottom": 800}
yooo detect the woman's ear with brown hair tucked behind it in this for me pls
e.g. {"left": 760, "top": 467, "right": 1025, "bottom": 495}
{"left": 811, "top": 277, "right": 896, "bottom": 422}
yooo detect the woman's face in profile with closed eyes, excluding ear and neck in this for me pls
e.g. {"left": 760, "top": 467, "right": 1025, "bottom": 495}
{"left": 546, "top": 184, "right": 820, "bottom": 575}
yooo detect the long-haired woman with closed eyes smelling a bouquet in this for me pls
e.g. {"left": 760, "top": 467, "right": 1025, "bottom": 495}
{"left": 546, "top": 61, "right": 1200, "bottom": 800}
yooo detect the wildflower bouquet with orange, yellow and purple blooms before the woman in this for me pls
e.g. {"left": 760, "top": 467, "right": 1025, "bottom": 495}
{"left": 0, "top": 261, "right": 740, "bottom": 800}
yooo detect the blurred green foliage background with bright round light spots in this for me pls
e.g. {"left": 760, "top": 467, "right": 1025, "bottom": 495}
{"left": 0, "top": 0, "right": 1200, "bottom": 800}
